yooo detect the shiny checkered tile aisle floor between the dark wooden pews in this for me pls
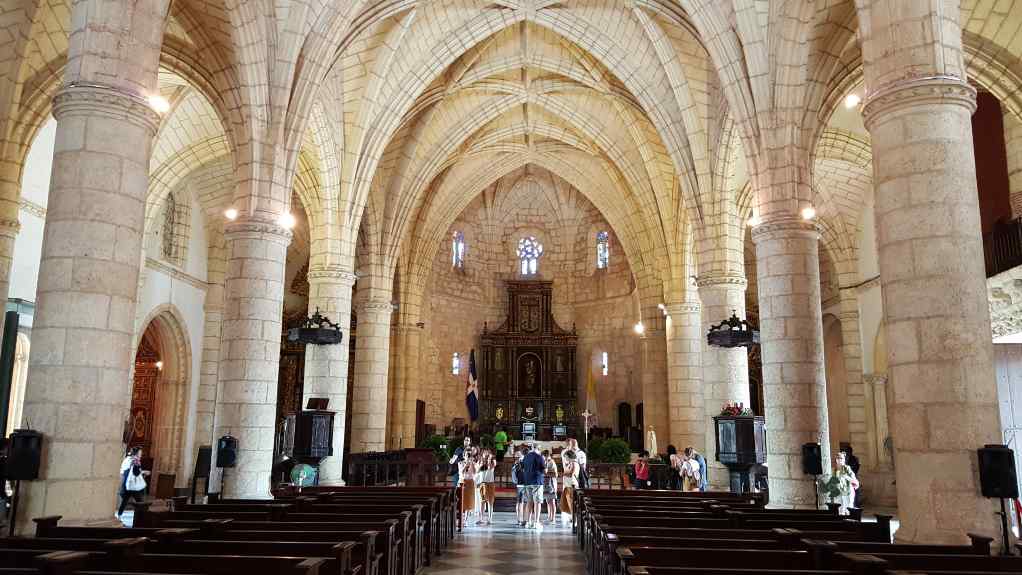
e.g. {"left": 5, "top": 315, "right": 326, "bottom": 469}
{"left": 423, "top": 513, "right": 586, "bottom": 575}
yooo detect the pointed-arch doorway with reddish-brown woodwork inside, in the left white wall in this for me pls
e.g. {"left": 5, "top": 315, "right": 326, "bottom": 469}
{"left": 125, "top": 304, "right": 191, "bottom": 490}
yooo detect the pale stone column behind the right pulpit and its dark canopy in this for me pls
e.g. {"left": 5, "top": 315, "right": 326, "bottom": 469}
{"left": 697, "top": 274, "right": 762, "bottom": 490}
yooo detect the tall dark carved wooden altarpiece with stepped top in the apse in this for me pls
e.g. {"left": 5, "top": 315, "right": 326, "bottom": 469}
{"left": 479, "top": 281, "right": 580, "bottom": 441}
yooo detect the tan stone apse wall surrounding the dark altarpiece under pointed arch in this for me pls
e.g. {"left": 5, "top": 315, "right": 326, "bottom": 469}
{"left": 421, "top": 171, "right": 642, "bottom": 433}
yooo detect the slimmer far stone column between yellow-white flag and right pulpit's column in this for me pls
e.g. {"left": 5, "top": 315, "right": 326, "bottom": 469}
{"left": 662, "top": 302, "right": 706, "bottom": 452}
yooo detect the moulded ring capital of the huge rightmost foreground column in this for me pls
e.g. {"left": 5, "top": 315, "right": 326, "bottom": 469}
{"left": 863, "top": 76, "right": 976, "bottom": 130}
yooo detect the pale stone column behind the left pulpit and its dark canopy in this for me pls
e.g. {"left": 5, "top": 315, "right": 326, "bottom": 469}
{"left": 303, "top": 266, "right": 355, "bottom": 485}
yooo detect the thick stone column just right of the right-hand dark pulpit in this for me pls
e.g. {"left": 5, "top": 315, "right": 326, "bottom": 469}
{"left": 752, "top": 219, "right": 831, "bottom": 508}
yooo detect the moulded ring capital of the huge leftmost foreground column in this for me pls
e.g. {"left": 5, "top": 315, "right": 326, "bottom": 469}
{"left": 53, "top": 84, "right": 160, "bottom": 136}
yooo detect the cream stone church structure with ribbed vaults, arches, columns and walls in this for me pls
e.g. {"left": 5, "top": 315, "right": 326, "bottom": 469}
{"left": 0, "top": 0, "right": 1022, "bottom": 542}
